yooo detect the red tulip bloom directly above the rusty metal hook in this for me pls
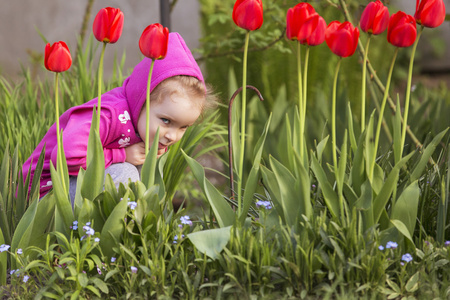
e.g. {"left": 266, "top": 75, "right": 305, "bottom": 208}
{"left": 233, "top": 0, "right": 263, "bottom": 31}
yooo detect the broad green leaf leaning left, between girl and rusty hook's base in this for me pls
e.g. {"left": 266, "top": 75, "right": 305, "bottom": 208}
{"left": 181, "top": 150, "right": 235, "bottom": 227}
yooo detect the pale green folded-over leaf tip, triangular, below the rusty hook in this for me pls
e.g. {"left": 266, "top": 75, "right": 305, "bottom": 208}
{"left": 187, "top": 226, "right": 231, "bottom": 259}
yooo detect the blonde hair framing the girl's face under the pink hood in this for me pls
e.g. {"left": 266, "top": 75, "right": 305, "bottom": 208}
{"left": 150, "top": 75, "right": 218, "bottom": 116}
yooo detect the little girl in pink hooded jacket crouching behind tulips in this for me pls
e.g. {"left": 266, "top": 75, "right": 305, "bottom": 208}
{"left": 22, "top": 32, "right": 214, "bottom": 201}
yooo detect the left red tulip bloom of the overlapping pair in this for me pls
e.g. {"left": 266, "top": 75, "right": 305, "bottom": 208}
{"left": 286, "top": 2, "right": 319, "bottom": 41}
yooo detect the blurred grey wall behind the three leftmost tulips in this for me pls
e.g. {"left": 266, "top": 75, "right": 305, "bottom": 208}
{"left": 0, "top": 0, "right": 200, "bottom": 79}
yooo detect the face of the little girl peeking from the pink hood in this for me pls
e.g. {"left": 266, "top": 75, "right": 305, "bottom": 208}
{"left": 137, "top": 93, "right": 201, "bottom": 157}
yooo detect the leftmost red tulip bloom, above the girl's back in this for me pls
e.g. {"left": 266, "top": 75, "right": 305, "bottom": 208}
{"left": 44, "top": 41, "right": 72, "bottom": 72}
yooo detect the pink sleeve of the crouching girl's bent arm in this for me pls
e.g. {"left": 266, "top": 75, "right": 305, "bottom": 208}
{"left": 51, "top": 109, "right": 126, "bottom": 175}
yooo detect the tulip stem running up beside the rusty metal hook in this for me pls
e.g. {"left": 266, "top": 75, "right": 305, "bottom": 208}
{"left": 237, "top": 31, "right": 250, "bottom": 216}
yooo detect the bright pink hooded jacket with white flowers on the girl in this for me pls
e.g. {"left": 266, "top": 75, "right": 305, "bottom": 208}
{"left": 22, "top": 32, "right": 204, "bottom": 197}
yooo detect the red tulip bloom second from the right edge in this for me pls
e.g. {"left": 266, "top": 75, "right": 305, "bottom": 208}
{"left": 387, "top": 11, "right": 417, "bottom": 47}
